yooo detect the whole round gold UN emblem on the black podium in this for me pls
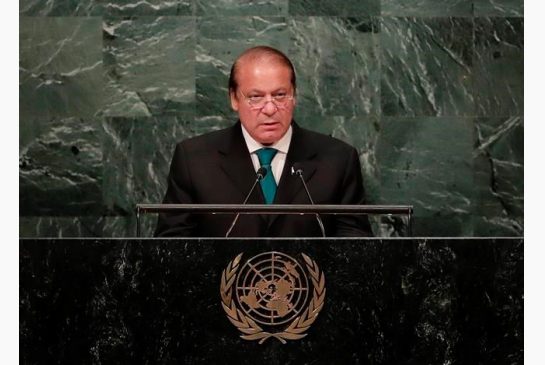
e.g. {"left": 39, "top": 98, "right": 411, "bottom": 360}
{"left": 220, "top": 251, "right": 325, "bottom": 344}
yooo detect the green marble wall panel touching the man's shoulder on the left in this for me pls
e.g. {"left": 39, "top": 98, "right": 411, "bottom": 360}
{"left": 104, "top": 116, "right": 190, "bottom": 215}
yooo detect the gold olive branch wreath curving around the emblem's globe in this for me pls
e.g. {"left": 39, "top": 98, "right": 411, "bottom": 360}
{"left": 220, "top": 253, "right": 326, "bottom": 344}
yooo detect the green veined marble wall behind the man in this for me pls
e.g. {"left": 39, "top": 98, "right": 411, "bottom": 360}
{"left": 19, "top": 0, "right": 524, "bottom": 237}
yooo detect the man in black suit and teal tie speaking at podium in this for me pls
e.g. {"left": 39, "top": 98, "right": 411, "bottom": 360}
{"left": 155, "top": 46, "right": 371, "bottom": 237}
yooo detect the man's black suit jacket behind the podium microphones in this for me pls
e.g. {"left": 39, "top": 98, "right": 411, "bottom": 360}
{"left": 155, "top": 122, "right": 371, "bottom": 237}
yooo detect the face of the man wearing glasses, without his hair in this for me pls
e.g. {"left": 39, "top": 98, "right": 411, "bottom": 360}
{"left": 230, "top": 60, "right": 295, "bottom": 145}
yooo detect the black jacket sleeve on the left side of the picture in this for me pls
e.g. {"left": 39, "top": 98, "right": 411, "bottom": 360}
{"left": 154, "top": 143, "right": 196, "bottom": 237}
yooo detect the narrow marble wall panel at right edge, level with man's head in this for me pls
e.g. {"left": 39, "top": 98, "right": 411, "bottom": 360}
{"left": 473, "top": 18, "right": 524, "bottom": 117}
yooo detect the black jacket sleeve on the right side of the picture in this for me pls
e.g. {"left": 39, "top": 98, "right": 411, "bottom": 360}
{"left": 335, "top": 148, "right": 373, "bottom": 237}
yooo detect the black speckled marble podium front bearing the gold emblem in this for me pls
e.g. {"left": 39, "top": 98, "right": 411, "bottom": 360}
{"left": 19, "top": 238, "right": 523, "bottom": 364}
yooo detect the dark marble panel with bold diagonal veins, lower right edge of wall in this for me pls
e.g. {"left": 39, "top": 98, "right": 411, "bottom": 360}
{"left": 474, "top": 117, "right": 524, "bottom": 236}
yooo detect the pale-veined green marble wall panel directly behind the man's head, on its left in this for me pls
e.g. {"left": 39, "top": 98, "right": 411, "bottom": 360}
{"left": 195, "top": 16, "right": 289, "bottom": 121}
